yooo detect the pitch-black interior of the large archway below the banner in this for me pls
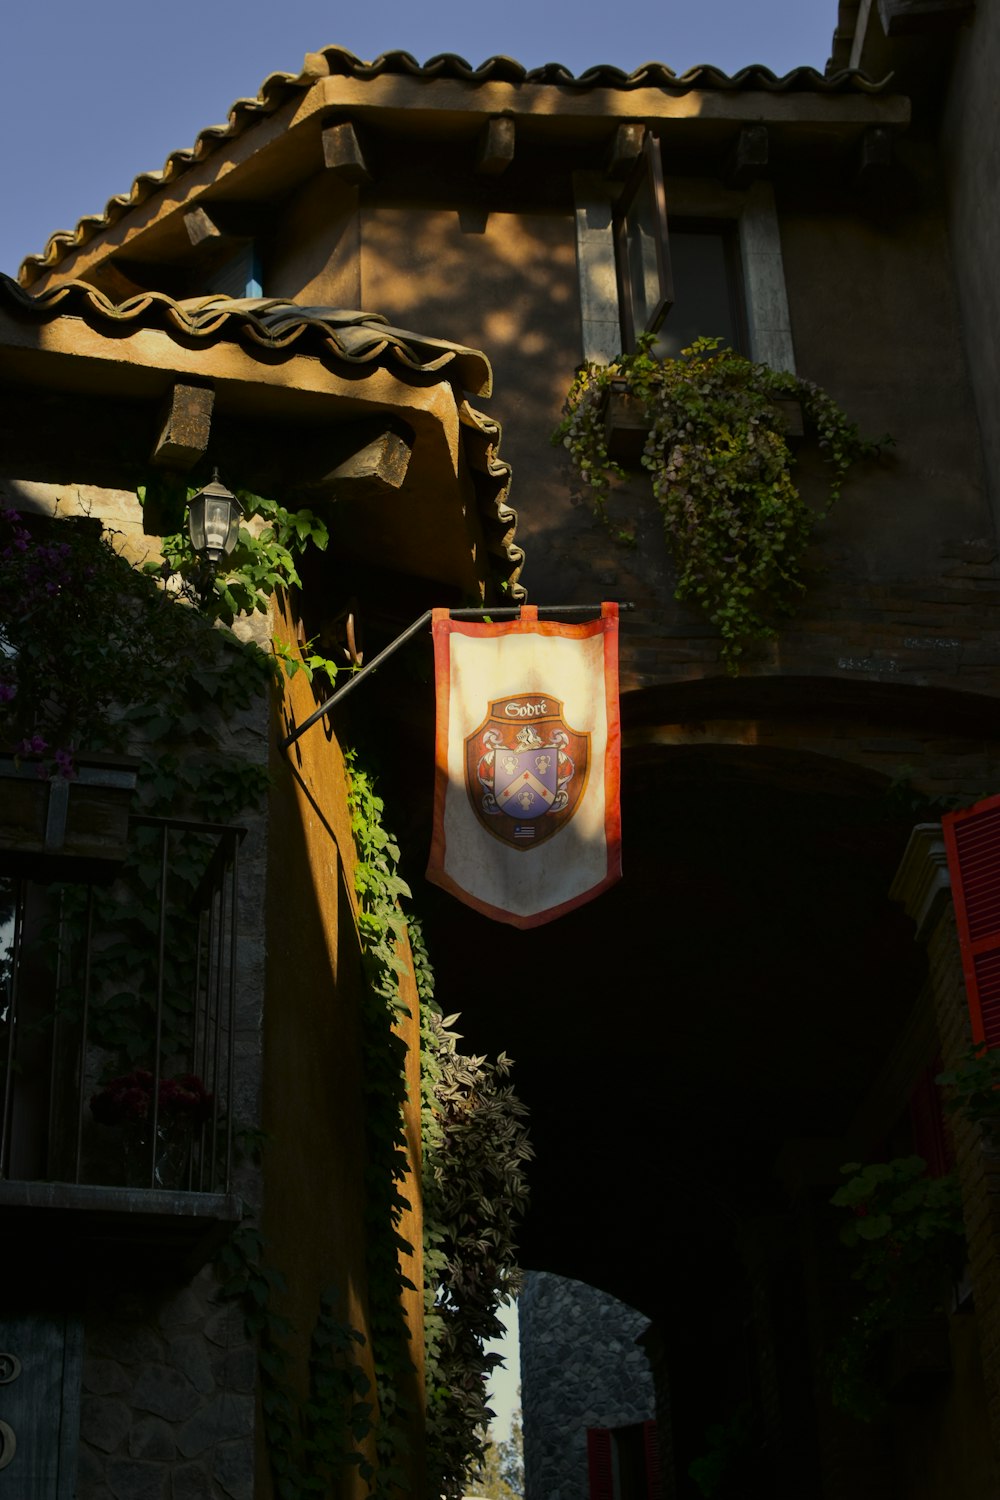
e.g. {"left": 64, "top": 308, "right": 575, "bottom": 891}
{"left": 421, "top": 746, "right": 924, "bottom": 1317}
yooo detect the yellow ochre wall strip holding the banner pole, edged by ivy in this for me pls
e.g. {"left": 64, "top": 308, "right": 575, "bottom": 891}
{"left": 259, "top": 591, "right": 423, "bottom": 1500}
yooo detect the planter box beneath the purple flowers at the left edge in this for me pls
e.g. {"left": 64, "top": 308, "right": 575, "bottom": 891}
{"left": 0, "top": 752, "right": 139, "bottom": 882}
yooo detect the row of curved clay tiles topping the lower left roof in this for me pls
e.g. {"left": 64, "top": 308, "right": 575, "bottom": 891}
{"left": 0, "top": 275, "right": 493, "bottom": 396}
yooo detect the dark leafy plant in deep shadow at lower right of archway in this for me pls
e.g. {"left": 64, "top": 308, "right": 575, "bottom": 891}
{"left": 829, "top": 1157, "right": 964, "bottom": 1421}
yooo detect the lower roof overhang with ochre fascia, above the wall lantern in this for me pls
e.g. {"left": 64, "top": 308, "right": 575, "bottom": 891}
{"left": 0, "top": 278, "right": 523, "bottom": 599}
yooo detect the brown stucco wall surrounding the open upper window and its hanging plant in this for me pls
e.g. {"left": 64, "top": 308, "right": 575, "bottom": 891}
{"left": 353, "top": 171, "right": 1000, "bottom": 692}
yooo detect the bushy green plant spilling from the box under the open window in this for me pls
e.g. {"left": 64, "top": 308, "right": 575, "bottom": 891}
{"left": 553, "top": 343, "right": 891, "bottom": 672}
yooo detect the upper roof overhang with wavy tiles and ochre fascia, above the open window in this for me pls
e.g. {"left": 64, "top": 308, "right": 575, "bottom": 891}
{"left": 21, "top": 48, "right": 910, "bottom": 291}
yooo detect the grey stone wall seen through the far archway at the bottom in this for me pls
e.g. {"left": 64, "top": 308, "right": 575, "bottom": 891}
{"left": 519, "top": 1271, "right": 655, "bottom": 1500}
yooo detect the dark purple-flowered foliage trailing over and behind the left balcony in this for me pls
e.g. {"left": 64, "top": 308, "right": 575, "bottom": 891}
{"left": 0, "top": 512, "right": 270, "bottom": 1073}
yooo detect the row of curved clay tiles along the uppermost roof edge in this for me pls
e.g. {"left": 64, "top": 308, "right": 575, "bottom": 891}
{"left": 18, "top": 47, "right": 889, "bottom": 285}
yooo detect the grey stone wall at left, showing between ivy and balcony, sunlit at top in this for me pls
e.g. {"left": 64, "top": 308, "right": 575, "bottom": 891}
{"left": 0, "top": 480, "right": 268, "bottom": 1500}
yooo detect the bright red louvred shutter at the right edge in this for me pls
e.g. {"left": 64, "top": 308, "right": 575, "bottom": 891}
{"left": 942, "top": 797, "right": 1000, "bottom": 1047}
